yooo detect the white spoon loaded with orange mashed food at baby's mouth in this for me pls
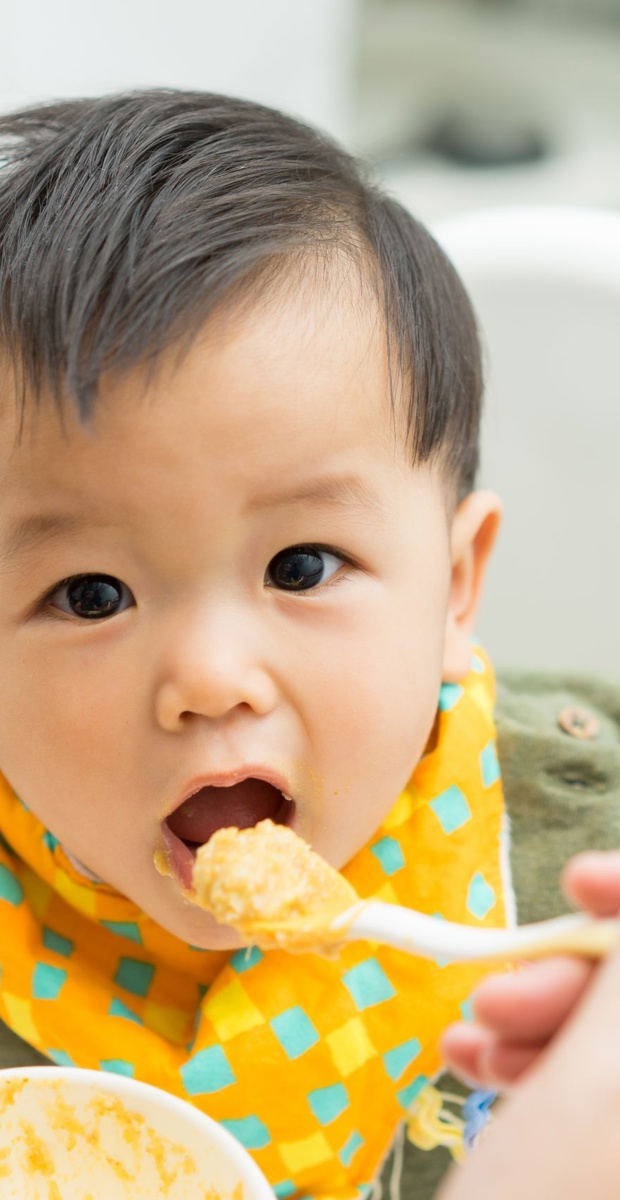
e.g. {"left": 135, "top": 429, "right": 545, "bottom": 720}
{"left": 189, "top": 820, "right": 620, "bottom": 962}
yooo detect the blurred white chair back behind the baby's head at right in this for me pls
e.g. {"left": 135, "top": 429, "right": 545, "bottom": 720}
{"left": 433, "top": 206, "right": 620, "bottom": 678}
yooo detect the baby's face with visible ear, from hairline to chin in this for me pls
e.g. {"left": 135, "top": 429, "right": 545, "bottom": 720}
{"left": 0, "top": 280, "right": 496, "bottom": 948}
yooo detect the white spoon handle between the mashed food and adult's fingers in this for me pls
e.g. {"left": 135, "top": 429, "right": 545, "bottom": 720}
{"left": 338, "top": 900, "right": 620, "bottom": 962}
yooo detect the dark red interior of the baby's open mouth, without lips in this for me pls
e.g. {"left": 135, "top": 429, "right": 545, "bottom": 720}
{"left": 167, "top": 779, "right": 288, "bottom": 845}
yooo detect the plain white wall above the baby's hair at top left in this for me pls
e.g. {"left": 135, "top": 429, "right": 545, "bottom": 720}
{"left": 0, "top": 0, "right": 356, "bottom": 138}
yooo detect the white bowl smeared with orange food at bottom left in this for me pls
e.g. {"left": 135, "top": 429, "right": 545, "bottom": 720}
{"left": 0, "top": 1067, "right": 273, "bottom": 1200}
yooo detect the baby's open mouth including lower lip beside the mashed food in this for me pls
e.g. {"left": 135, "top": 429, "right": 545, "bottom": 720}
{"left": 162, "top": 778, "right": 295, "bottom": 889}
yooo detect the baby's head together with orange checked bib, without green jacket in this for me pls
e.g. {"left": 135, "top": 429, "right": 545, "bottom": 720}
{"left": 0, "top": 91, "right": 597, "bottom": 1198}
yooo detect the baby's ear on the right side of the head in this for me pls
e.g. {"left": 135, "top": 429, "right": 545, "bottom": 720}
{"left": 443, "top": 491, "right": 501, "bottom": 683}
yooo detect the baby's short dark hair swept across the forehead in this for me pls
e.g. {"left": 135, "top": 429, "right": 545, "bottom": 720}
{"left": 0, "top": 90, "right": 482, "bottom": 496}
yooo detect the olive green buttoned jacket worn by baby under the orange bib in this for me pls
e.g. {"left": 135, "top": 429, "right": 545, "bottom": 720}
{"left": 0, "top": 673, "right": 620, "bottom": 1200}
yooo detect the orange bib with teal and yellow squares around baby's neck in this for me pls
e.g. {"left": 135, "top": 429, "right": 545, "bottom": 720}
{"left": 0, "top": 650, "right": 506, "bottom": 1198}
